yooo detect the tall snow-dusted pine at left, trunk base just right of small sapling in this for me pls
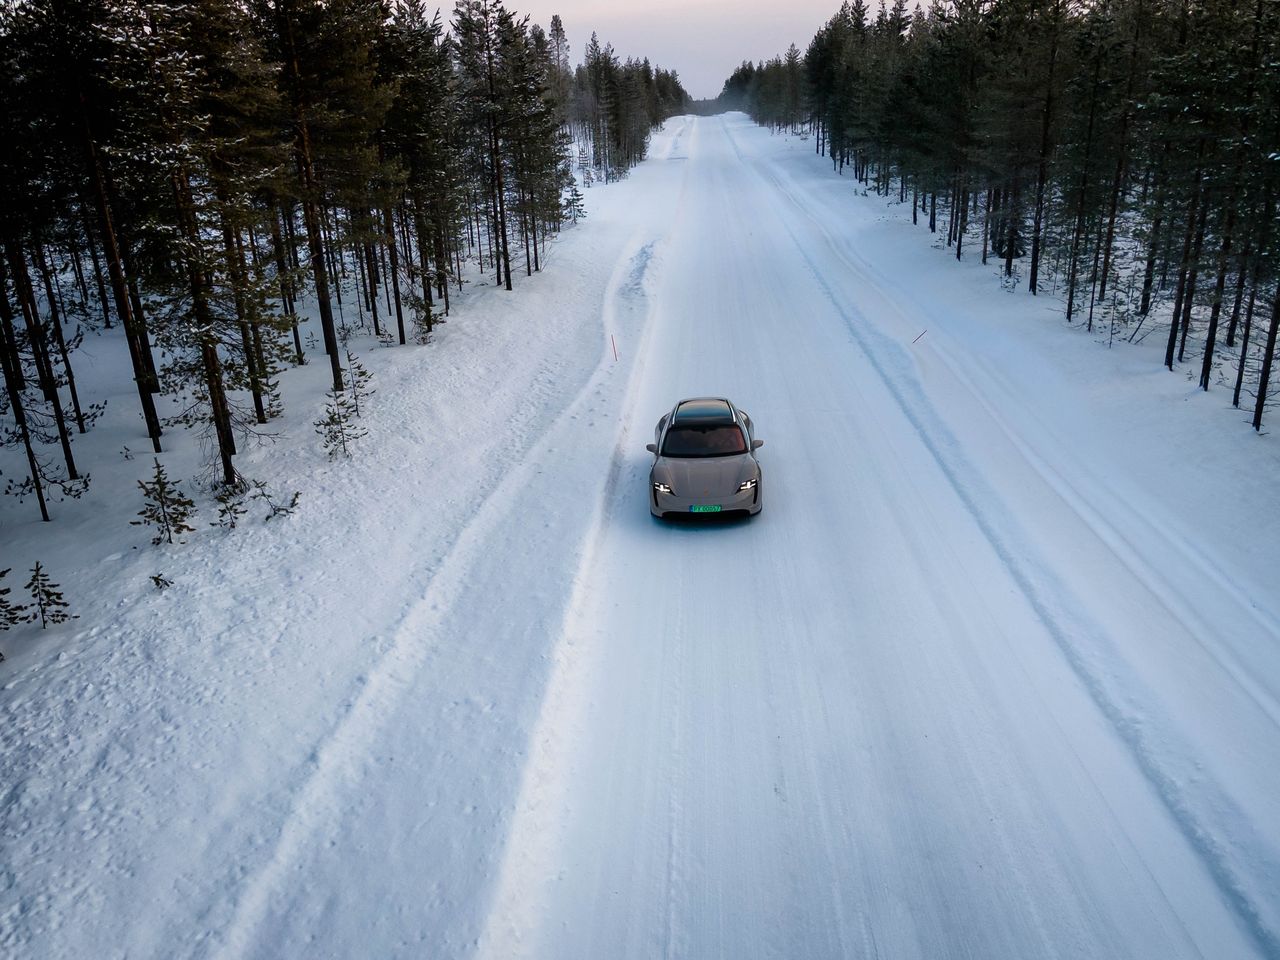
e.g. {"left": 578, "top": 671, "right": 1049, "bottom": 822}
{"left": 122, "top": 0, "right": 298, "bottom": 485}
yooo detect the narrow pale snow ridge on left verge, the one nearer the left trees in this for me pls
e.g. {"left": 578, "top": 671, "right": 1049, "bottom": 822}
{"left": 204, "top": 241, "right": 655, "bottom": 960}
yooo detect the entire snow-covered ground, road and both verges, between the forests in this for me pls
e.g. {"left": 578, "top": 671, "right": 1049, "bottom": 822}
{"left": 0, "top": 115, "right": 1280, "bottom": 960}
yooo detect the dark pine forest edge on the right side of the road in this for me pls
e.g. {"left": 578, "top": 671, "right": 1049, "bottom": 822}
{"left": 721, "top": 0, "right": 1280, "bottom": 429}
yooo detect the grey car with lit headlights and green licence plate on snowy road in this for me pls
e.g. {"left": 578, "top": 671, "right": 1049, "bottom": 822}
{"left": 645, "top": 397, "right": 764, "bottom": 518}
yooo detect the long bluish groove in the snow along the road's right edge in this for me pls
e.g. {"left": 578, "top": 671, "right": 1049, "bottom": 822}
{"left": 726, "top": 125, "right": 1280, "bottom": 959}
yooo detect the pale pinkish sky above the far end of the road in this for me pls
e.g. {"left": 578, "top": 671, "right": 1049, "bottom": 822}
{"left": 504, "top": 0, "right": 840, "bottom": 100}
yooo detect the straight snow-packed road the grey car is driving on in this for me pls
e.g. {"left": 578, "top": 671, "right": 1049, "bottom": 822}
{"left": 481, "top": 120, "right": 1276, "bottom": 957}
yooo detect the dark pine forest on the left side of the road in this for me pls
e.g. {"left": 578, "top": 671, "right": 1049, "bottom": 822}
{"left": 0, "top": 0, "right": 686, "bottom": 520}
